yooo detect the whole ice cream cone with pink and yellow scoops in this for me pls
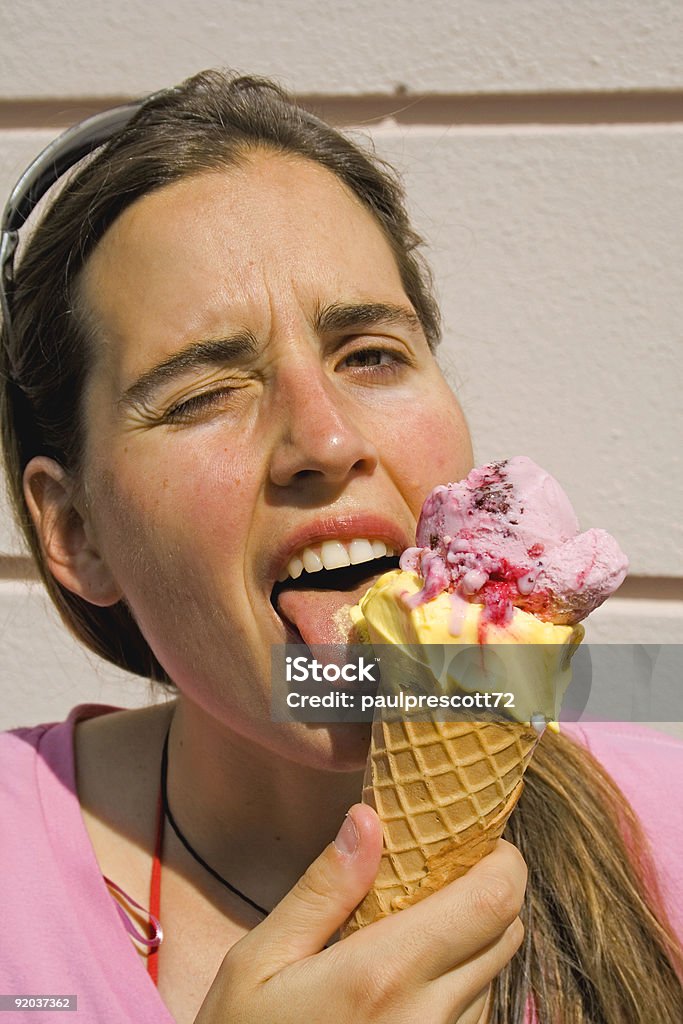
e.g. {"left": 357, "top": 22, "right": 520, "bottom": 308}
{"left": 345, "top": 456, "right": 628, "bottom": 932}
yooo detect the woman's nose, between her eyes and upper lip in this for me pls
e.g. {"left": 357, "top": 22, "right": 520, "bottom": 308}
{"left": 270, "top": 365, "right": 379, "bottom": 487}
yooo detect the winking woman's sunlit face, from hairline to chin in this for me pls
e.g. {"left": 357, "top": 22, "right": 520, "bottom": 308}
{"left": 74, "top": 153, "right": 471, "bottom": 763}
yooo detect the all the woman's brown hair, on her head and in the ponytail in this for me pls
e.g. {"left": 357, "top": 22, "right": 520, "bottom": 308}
{"left": 0, "top": 72, "right": 683, "bottom": 1024}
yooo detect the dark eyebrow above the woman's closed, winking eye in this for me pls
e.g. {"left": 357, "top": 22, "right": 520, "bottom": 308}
{"left": 119, "top": 331, "right": 258, "bottom": 406}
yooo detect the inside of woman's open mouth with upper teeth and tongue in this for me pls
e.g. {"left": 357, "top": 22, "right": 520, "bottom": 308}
{"left": 270, "top": 539, "right": 398, "bottom": 646}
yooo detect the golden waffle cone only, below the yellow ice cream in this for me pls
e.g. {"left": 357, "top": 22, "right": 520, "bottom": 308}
{"left": 343, "top": 716, "right": 539, "bottom": 935}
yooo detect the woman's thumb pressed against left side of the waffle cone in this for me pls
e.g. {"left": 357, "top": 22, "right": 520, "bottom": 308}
{"left": 251, "top": 804, "right": 382, "bottom": 973}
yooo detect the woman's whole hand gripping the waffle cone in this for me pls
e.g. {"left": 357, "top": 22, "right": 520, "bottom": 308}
{"left": 195, "top": 804, "right": 526, "bottom": 1024}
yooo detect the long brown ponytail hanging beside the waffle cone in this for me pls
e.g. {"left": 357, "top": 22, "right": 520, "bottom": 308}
{"left": 497, "top": 730, "right": 683, "bottom": 1024}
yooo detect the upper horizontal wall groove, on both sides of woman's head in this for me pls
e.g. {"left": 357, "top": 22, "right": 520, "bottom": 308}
{"left": 0, "top": 90, "right": 683, "bottom": 130}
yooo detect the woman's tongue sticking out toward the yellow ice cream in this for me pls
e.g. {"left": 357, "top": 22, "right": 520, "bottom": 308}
{"left": 278, "top": 573, "right": 380, "bottom": 647}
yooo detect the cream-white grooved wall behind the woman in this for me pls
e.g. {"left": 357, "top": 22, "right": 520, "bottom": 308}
{"left": 0, "top": 0, "right": 683, "bottom": 734}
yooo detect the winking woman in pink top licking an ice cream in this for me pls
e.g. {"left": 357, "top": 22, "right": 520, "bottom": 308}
{"left": 0, "top": 73, "right": 683, "bottom": 1024}
